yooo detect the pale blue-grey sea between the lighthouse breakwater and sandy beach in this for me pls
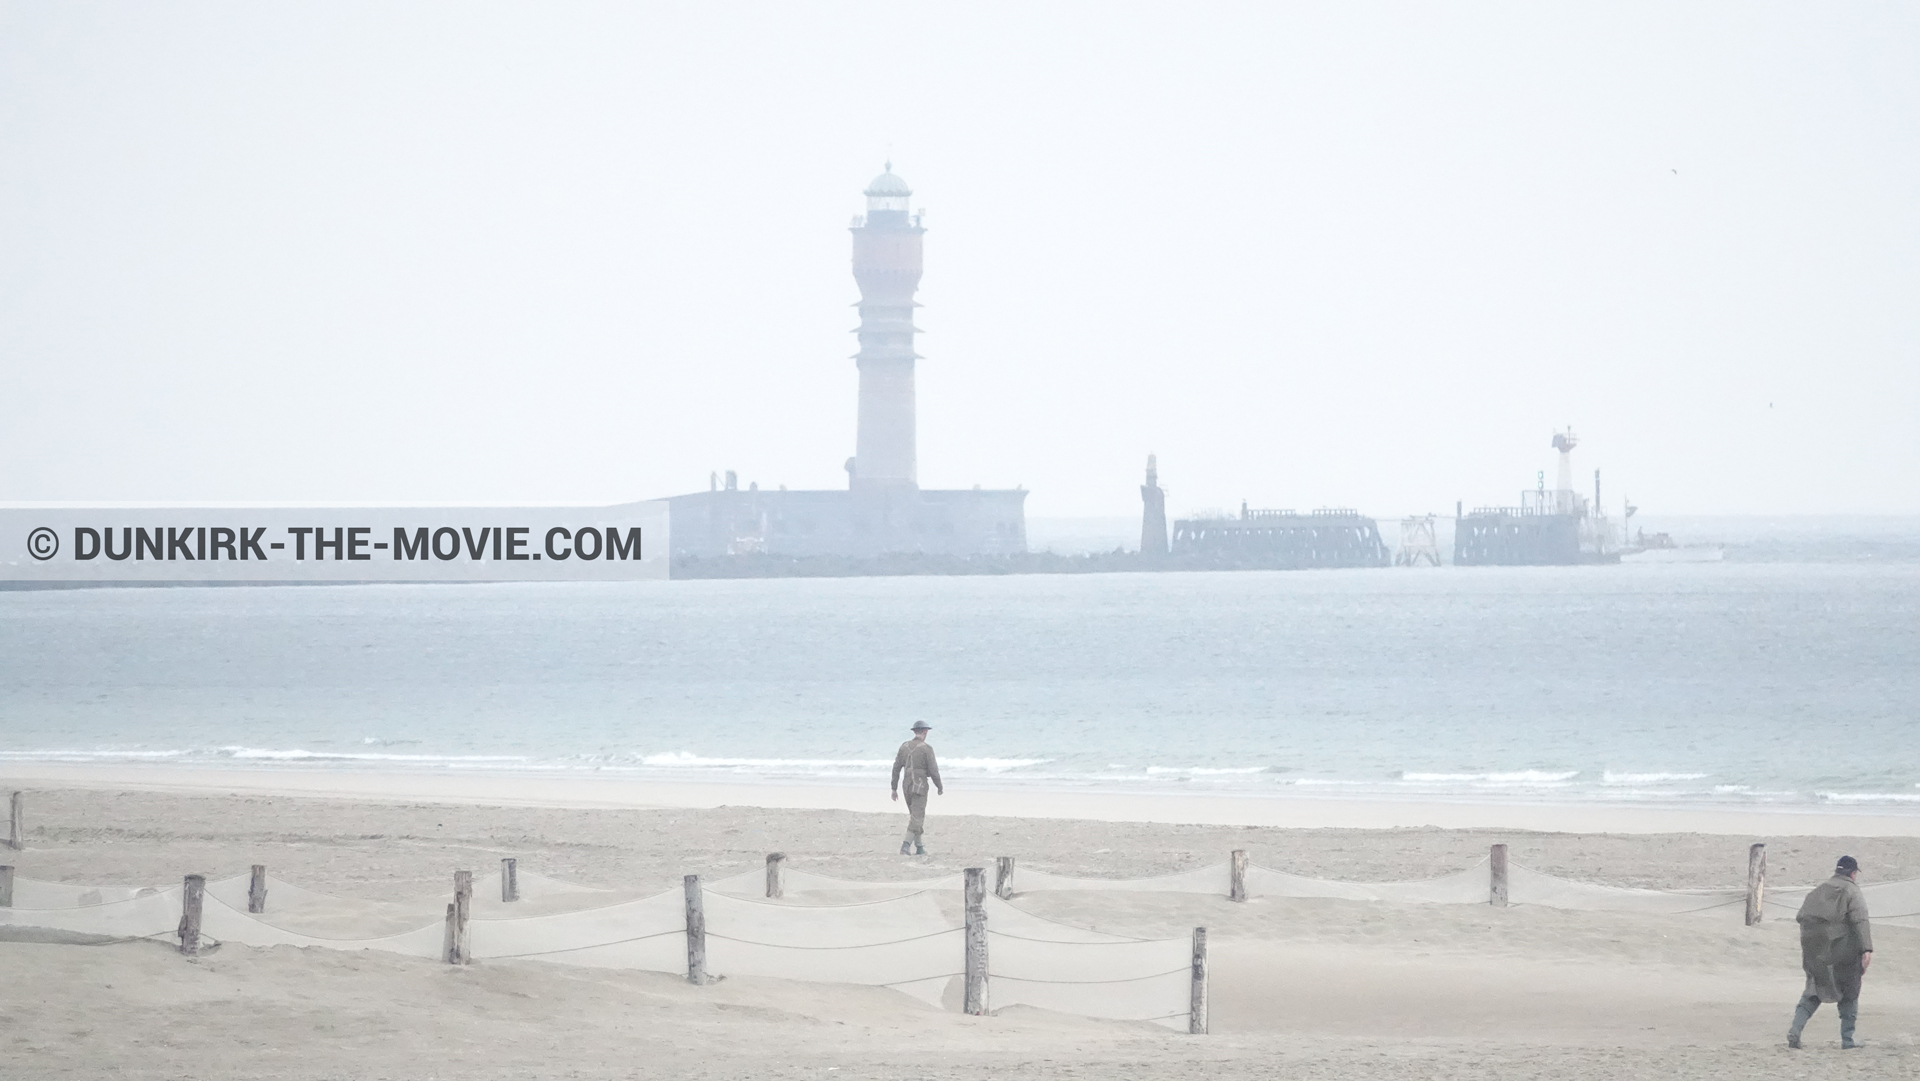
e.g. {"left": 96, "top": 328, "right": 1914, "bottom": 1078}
{"left": 0, "top": 563, "right": 1920, "bottom": 812}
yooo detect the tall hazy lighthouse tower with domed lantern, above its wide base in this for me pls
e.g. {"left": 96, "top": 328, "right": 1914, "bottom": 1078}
{"left": 847, "top": 161, "right": 925, "bottom": 492}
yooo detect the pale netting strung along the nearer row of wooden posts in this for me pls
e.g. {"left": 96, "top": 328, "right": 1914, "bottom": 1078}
{"left": 0, "top": 876, "right": 1188, "bottom": 1027}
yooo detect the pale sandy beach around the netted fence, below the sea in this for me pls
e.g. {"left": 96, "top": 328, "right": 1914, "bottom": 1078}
{"left": 0, "top": 766, "right": 1920, "bottom": 1079}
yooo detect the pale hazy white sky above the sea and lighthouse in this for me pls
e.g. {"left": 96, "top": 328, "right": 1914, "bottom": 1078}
{"left": 0, "top": 2, "right": 1920, "bottom": 516}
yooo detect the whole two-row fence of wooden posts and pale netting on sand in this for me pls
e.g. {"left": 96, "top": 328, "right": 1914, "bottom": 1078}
{"left": 0, "top": 845, "right": 1920, "bottom": 1033}
